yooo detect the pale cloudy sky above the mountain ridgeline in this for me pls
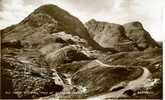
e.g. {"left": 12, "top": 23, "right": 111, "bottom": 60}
{"left": 0, "top": 0, "right": 165, "bottom": 41}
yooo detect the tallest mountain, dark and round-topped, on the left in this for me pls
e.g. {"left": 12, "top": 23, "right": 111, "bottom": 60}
{"left": 3, "top": 4, "right": 103, "bottom": 50}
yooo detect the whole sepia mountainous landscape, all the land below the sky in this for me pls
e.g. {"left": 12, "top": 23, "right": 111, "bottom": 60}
{"left": 0, "top": 5, "right": 163, "bottom": 99}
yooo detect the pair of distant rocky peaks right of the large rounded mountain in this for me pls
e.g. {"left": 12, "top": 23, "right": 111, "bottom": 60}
{"left": 85, "top": 19, "right": 159, "bottom": 51}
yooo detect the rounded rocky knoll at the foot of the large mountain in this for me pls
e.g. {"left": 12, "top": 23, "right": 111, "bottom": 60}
{"left": 45, "top": 45, "right": 92, "bottom": 67}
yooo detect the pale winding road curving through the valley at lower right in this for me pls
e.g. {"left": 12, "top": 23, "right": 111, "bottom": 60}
{"left": 88, "top": 60, "right": 151, "bottom": 100}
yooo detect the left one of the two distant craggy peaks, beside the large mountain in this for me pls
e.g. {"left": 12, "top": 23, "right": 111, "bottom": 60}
{"left": 86, "top": 20, "right": 137, "bottom": 51}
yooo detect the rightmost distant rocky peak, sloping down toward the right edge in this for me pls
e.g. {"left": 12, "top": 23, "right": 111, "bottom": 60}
{"left": 123, "top": 22, "right": 160, "bottom": 50}
